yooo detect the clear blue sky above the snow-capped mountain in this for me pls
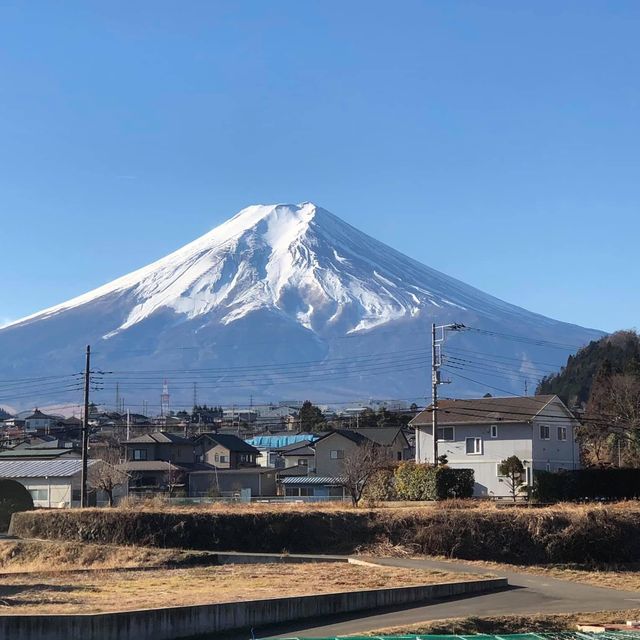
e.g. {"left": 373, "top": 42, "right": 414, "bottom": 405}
{"left": 0, "top": 0, "right": 640, "bottom": 330}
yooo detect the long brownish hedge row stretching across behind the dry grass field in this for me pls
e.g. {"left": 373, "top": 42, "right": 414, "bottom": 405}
{"left": 12, "top": 503, "right": 640, "bottom": 564}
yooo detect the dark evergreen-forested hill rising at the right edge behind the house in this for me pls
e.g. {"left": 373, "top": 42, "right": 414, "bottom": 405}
{"left": 537, "top": 331, "right": 640, "bottom": 407}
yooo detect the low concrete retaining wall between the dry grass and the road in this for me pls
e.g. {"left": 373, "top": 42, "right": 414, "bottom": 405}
{"left": 0, "top": 578, "right": 507, "bottom": 640}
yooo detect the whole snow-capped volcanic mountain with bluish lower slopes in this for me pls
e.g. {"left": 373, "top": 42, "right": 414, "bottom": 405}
{"left": 0, "top": 202, "right": 603, "bottom": 408}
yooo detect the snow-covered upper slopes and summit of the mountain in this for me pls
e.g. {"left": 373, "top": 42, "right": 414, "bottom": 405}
{"left": 8, "top": 202, "right": 544, "bottom": 339}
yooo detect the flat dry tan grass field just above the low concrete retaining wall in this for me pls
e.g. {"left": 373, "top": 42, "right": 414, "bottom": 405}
{"left": 0, "top": 563, "right": 480, "bottom": 615}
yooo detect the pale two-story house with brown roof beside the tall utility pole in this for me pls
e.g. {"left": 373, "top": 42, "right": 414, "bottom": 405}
{"left": 410, "top": 395, "right": 580, "bottom": 497}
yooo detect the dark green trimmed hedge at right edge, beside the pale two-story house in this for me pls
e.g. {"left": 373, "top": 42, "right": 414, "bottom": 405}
{"left": 534, "top": 469, "right": 640, "bottom": 502}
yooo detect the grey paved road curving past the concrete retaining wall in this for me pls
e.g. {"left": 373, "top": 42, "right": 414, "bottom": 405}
{"left": 256, "top": 558, "right": 640, "bottom": 638}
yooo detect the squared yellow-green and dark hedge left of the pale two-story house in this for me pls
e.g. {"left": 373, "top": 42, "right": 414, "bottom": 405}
{"left": 394, "top": 462, "right": 474, "bottom": 500}
